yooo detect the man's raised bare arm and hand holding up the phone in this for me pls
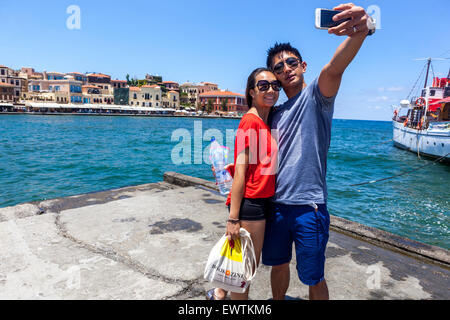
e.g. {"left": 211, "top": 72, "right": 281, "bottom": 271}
{"left": 319, "top": 3, "right": 370, "bottom": 97}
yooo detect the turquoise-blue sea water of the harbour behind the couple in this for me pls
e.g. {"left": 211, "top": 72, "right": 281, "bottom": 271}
{"left": 0, "top": 115, "right": 450, "bottom": 249}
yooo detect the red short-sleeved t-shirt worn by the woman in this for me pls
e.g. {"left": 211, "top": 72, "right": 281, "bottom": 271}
{"left": 226, "top": 113, "right": 278, "bottom": 205}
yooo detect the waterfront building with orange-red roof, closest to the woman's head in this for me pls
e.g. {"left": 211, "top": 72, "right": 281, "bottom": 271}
{"left": 199, "top": 91, "right": 248, "bottom": 114}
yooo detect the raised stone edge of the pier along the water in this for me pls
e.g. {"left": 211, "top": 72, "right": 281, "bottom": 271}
{"left": 164, "top": 171, "right": 450, "bottom": 269}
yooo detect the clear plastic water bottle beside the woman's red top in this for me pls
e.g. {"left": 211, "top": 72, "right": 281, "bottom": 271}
{"left": 209, "top": 137, "right": 233, "bottom": 195}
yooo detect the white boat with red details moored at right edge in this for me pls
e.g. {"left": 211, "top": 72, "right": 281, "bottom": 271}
{"left": 392, "top": 58, "right": 450, "bottom": 162}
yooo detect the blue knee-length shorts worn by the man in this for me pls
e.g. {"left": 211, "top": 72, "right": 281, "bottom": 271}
{"left": 262, "top": 203, "right": 330, "bottom": 286}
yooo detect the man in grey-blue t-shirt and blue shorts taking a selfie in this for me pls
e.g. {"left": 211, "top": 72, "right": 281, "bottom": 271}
{"left": 262, "top": 4, "right": 375, "bottom": 299}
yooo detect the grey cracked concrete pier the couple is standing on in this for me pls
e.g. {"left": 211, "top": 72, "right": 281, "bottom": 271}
{"left": 0, "top": 173, "right": 450, "bottom": 300}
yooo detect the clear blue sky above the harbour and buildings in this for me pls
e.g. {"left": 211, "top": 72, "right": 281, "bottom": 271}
{"left": 0, "top": 0, "right": 450, "bottom": 120}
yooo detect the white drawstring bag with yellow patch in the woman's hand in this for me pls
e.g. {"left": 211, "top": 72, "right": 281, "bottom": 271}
{"left": 204, "top": 228, "right": 256, "bottom": 293}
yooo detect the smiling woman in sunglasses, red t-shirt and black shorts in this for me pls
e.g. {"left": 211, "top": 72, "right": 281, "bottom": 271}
{"left": 207, "top": 68, "right": 281, "bottom": 300}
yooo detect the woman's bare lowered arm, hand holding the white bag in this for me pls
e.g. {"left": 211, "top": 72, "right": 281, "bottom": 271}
{"left": 226, "top": 148, "right": 249, "bottom": 240}
